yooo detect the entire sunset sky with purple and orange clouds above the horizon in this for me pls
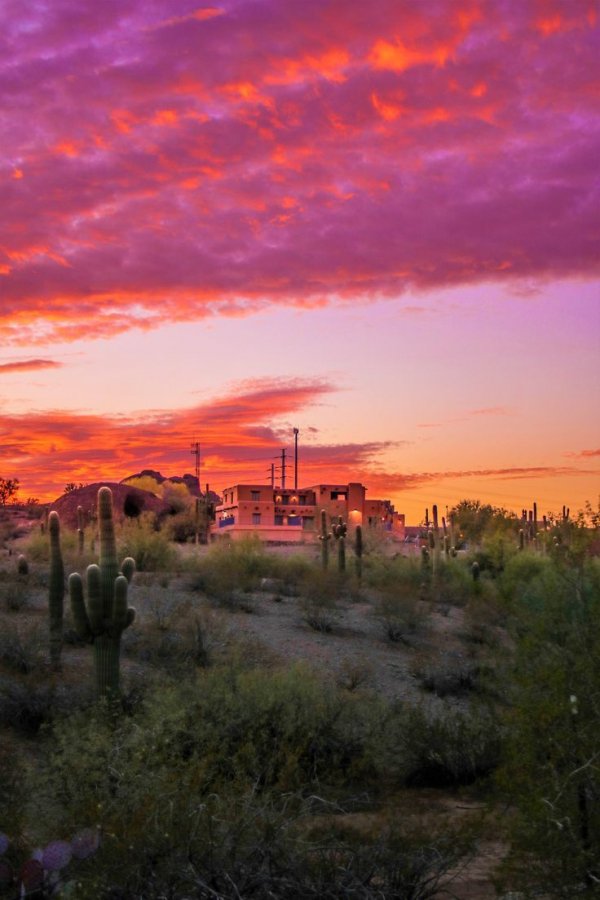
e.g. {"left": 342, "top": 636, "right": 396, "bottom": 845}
{"left": 0, "top": 0, "right": 600, "bottom": 524}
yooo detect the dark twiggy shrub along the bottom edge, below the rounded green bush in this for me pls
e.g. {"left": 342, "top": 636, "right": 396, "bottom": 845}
{"left": 23, "top": 783, "right": 474, "bottom": 900}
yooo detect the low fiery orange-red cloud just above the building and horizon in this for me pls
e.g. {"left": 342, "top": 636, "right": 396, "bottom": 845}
{"left": 0, "top": 378, "right": 598, "bottom": 500}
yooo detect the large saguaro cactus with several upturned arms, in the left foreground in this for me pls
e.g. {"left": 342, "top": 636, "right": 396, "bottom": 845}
{"left": 69, "top": 487, "right": 135, "bottom": 697}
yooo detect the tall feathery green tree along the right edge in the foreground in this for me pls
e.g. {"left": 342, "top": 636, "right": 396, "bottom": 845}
{"left": 499, "top": 544, "right": 600, "bottom": 898}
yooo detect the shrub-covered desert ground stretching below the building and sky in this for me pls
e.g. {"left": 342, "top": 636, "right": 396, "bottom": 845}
{"left": 0, "top": 487, "right": 600, "bottom": 900}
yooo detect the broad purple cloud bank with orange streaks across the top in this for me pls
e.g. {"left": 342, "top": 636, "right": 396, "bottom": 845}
{"left": 0, "top": 0, "right": 600, "bottom": 344}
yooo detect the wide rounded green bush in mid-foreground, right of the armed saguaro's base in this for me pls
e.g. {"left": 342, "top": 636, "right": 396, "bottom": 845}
{"left": 30, "top": 666, "right": 379, "bottom": 828}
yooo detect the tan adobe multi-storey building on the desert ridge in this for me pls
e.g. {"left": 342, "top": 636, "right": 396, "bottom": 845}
{"left": 213, "top": 482, "right": 405, "bottom": 542}
